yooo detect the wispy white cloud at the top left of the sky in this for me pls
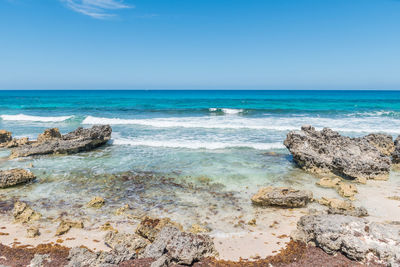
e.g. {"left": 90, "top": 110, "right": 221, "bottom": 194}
{"left": 62, "top": 0, "right": 134, "bottom": 19}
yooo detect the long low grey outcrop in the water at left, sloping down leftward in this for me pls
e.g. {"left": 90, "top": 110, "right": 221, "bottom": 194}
{"left": 10, "top": 125, "right": 112, "bottom": 158}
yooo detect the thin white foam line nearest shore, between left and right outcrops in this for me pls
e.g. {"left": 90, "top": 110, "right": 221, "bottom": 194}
{"left": 112, "top": 138, "right": 284, "bottom": 150}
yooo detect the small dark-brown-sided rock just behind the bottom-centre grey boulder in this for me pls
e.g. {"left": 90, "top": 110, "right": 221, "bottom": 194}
{"left": 136, "top": 216, "right": 183, "bottom": 242}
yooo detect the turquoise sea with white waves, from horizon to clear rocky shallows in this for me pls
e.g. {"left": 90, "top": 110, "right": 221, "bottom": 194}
{"left": 0, "top": 91, "right": 400, "bottom": 231}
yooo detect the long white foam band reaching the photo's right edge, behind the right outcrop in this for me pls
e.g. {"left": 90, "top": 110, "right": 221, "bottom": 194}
{"left": 82, "top": 116, "right": 400, "bottom": 134}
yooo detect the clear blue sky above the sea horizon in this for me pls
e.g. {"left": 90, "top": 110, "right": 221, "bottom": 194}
{"left": 0, "top": 0, "right": 400, "bottom": 90}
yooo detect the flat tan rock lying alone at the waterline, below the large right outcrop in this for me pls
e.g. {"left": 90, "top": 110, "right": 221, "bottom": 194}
{"left": 251, "top": 186, "right": 313, "bottom": 208}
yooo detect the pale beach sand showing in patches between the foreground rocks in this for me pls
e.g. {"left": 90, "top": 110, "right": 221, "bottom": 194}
{"left": 0, "top": 173, "right": 400, "bottom": 261}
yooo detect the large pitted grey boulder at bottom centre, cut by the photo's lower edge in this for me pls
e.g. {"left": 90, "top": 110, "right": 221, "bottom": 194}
{"left": 141, "top": 226, "right": 217, "bottom": 266}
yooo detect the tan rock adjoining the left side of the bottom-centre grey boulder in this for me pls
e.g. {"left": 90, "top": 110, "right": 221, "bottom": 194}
{"left": 104, "top": 231, "right": 150, "bottom": 259}
